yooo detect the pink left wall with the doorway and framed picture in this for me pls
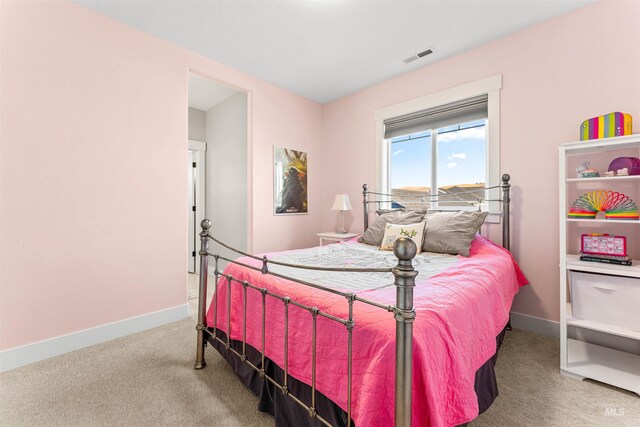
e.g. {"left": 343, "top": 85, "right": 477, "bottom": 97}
{"left": 0, "top": 2, "right": 322, "bottom": 349}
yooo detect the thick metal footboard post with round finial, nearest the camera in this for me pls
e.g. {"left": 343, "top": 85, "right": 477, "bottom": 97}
{"left": 393, "top": 237, "right": 418, "bottom": 427}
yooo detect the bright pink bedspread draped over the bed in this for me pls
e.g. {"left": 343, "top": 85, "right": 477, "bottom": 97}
{"left": 207, "top": 236, "right": 527, "bottom": 427}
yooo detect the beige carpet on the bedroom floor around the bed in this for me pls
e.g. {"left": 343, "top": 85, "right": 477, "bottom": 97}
{"left": 0, "top": 319, "right": 640, "bottom": 427}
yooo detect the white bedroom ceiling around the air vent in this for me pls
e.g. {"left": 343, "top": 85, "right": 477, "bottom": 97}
{"left": 75, "top": 0, "right": 595, "bottom": 103}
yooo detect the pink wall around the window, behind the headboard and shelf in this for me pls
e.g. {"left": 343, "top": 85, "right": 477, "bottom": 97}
{"left": 323, "top": 1, "right": 640, "bottom": 320}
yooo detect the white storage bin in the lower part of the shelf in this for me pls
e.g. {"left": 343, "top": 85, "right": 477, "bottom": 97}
{"left": 569, "top": 271, "right": 640, "bottom": 331}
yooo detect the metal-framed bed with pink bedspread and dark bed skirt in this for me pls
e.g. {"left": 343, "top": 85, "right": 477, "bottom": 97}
{"left": 195, "top": 175, "right": 526, "bottom": 426}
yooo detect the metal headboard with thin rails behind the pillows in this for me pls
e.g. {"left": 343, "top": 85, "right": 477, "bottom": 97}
{"left": 362, "top": 173, "right": 511, "bottom": 249}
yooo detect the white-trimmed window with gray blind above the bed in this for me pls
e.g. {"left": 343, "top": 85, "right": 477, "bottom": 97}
{"left": 376, "top": 75, "right": 502, "bottom": 217}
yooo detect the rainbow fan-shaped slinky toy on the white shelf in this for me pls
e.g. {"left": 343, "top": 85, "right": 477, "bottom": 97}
{"left": 568, "top": 190, "right": 640, "bottom": 220}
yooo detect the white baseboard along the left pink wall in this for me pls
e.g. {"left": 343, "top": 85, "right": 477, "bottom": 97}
{"left": 0, "top": 304, "right": 189, "bottom": 372}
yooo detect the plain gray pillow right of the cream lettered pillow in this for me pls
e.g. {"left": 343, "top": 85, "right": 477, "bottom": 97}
{"left": 422, "top": 211, "right": 489, "bottom": 256}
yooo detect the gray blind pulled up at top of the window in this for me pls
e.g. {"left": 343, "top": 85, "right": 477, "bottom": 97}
{"left": 383, "top": 94, "right": 488, "bottom": 139}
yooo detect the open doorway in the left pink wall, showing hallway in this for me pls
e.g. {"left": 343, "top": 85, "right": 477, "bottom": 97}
{"left": 186, "top": 73, "right": 250, "bottom": 314}
